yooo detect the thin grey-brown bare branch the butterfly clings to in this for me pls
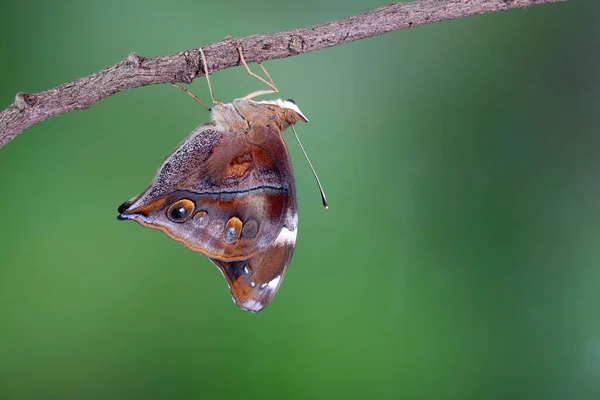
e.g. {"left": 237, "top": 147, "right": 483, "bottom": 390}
{"left": 0, "top": 0, "right": 566, "bottom": 148}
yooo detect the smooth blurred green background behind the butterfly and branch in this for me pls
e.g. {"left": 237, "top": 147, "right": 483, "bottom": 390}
{"left": 0, "top": 0, "right": 600, "bottom": 399}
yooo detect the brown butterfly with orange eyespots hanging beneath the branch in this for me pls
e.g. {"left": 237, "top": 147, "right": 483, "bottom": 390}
{"left": 118, "top": 49, "right": 327, "bottom": 312}
